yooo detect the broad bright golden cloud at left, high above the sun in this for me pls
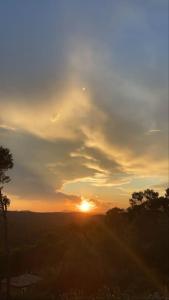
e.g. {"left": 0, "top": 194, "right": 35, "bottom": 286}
{"left": 1, "top": 86, "right": 91, "bottom": 139}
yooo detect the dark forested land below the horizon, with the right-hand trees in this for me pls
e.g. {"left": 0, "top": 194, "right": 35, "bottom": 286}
{"left": 0, "top": 189, "right": 169, "bottom": 299}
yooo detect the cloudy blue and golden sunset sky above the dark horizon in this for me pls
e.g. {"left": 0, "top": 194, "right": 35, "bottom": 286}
{"left": 0, "top": 0, "right": 169, "bottom": 211}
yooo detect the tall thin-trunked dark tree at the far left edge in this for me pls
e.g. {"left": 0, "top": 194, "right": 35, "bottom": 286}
{"left": 0, "top": 146, "right": 13, "bottom": 300}
